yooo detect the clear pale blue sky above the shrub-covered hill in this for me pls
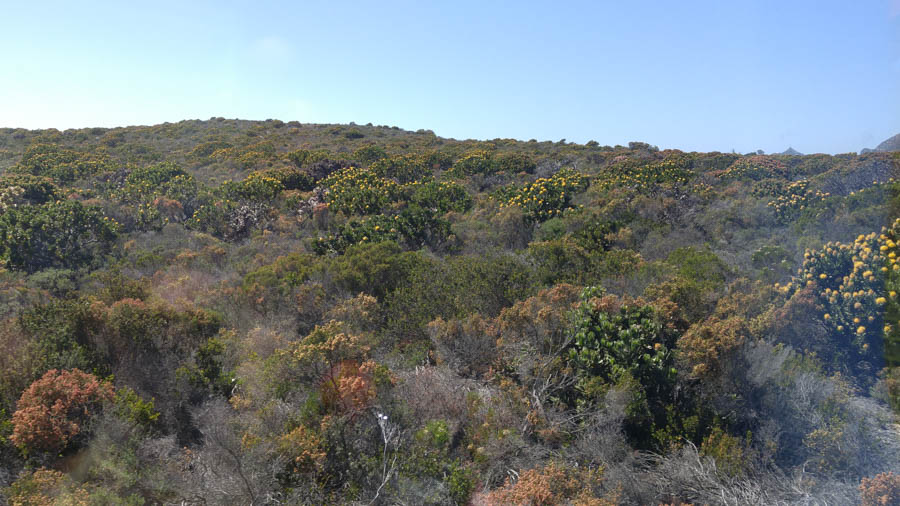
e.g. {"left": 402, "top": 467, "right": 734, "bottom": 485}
{"left": 0, "top": 0, "right": 900, "bottom": 153}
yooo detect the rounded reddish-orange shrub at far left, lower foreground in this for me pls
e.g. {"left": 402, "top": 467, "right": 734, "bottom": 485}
{"left": 10, "top": 369, "right": 113, "bottom": 451}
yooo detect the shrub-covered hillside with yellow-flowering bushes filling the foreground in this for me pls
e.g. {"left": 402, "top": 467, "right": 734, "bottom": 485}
{"left": 0, "top": 118, "right": 900, "bottom": 505}
